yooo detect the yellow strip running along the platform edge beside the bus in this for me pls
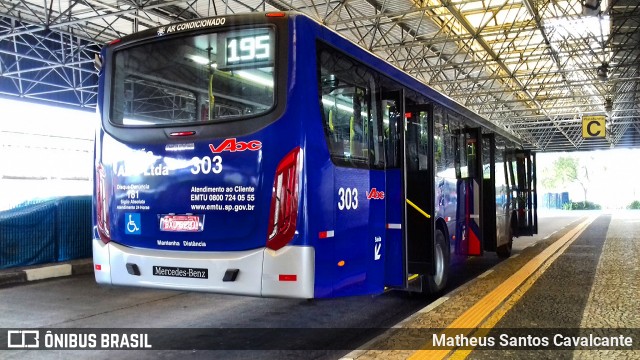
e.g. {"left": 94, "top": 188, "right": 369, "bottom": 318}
{"left": 345, "top": 217, "right": 596, "bottom": 360}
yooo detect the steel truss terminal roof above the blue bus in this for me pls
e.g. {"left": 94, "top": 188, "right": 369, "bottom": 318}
{"left": 0, "top": 0, "right": 640, "bottom": 151}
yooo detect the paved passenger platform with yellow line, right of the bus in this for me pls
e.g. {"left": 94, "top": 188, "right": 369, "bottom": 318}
{"left": 344, "top": 211, "right": 640, "bottom": 359}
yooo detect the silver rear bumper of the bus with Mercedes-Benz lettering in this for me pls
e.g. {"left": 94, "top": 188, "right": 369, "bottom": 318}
{"left": 93, "top": 239, "right": 314, "bottom": 298}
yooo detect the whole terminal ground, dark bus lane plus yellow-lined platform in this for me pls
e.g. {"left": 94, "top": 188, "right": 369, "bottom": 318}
{"left": 0, "top": 212, "right": 640, "bottom": 360}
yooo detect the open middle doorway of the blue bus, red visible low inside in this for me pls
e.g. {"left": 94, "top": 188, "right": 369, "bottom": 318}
{"left": 453, "top": 128, "right": 483, "bottom": 255}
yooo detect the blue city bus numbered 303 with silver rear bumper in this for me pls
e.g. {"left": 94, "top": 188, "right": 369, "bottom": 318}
{"left": 93, "top": 12, "right": 537, "bottom": 299}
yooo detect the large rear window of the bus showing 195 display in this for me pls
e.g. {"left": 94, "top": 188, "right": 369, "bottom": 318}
{"left": 111, "top": 27, "right": 275, "bottom": 126}
